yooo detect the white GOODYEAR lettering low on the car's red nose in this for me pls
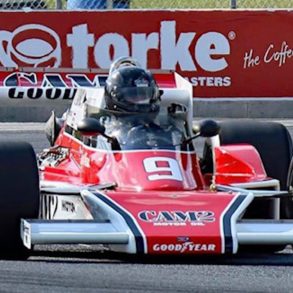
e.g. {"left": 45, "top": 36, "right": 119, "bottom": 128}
{"left": 153, "top": 241, "right": 216, "bottom": 253}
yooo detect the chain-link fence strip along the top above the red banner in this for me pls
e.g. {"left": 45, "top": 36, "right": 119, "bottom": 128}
{"left": 0, "top": 0, "right": 293, "bottom": 10}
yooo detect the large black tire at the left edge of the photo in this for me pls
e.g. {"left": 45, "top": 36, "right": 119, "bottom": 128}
{"left": 0, "top": 142, "right": 40, "bottom": 259}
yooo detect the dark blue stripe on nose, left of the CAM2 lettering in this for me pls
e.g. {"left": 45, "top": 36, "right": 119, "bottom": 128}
{"left": 93, "top": 193, "right": 145, "bottom": 254}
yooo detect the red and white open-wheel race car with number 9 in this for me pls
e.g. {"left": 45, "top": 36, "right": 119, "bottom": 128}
{"left": 0, "top": 59, "right": 293, "bottom": 257}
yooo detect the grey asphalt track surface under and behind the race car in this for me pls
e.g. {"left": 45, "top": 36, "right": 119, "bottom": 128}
{"left": 0, "top": 120, "right": 293, "bottom": 293}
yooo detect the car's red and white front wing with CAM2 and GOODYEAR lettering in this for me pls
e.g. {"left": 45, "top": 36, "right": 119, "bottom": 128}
{"left": 21, "top": 181, "right": 293, "bottom": 254}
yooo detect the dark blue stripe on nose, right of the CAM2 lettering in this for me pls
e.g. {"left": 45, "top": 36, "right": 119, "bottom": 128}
{"left": 223, "top": 194, "right": 247, "bottom": 253}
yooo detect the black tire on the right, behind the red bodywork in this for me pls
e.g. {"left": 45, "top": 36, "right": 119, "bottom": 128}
{"left": 220, "top": 120, "right": 293, "bottom": 252}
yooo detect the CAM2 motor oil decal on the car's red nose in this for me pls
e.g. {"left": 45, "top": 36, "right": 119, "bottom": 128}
{"left": 138, "top": 210, "right": 215, "bottom": 226}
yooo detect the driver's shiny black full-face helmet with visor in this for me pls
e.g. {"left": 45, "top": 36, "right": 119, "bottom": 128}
{"left": 105, "top": 66, "right": 160, "bottom": 114}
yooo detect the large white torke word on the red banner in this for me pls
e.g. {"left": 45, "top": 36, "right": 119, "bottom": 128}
{"left": 67, "top": 20, "right": 231, "bottom": 72}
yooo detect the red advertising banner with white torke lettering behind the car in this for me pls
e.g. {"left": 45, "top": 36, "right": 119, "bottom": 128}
{"left": 0, "top": 10, "right": 293, "bottom": 98}
